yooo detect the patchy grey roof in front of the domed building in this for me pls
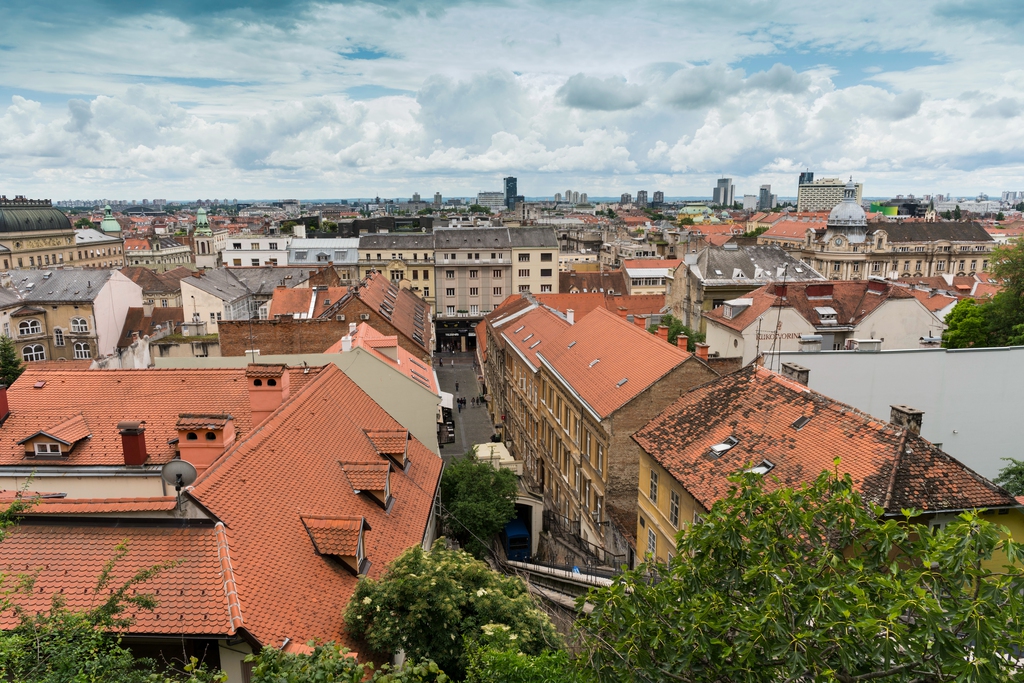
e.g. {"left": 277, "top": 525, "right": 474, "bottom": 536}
{"left": 691, "top": 245, "right": 824, "bottom": 285}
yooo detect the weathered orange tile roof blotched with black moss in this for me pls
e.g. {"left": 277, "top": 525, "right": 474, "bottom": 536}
{"left": 633, "top": 366, "right": 1016, "bottom": 514}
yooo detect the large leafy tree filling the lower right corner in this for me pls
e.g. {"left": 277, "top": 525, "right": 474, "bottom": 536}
{"left": 580, "top": 472, "right": 1024, "bottom": 683}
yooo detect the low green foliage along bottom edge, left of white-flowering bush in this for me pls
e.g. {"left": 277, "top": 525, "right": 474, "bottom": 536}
{"left": 246, "top": 643, "right": 450, "bottom": 683}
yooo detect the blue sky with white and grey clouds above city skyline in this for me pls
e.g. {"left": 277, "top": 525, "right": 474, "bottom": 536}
{"left": 0, "top": 0, "right": 1024, "bottom": 200}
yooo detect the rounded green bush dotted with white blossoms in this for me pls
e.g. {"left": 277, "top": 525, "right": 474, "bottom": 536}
{"left": 345, "top": 540, "right": 561, "bottom": 680}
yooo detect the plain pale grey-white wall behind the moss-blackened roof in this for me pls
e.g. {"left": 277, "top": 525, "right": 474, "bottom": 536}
{"left": 772, "top": 346, "right": 1024, "bottom": 478}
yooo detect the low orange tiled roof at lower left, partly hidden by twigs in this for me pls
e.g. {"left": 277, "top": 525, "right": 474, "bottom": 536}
{"left": 0, "top": 524, "right": 240, "bottom": 636}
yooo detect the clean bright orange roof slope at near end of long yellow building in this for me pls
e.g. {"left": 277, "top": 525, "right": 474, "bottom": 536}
{"left": 538, "top": 308, "right": 690, "bottom": 419}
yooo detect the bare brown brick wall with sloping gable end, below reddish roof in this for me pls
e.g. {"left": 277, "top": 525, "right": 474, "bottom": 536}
{"left": 217, "top": 297, "right": 430, "bottom": 362}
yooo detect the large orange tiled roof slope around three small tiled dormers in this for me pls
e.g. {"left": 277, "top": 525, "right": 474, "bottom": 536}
{"left": 190, "top": 365, "right": 441, "bottom": 646}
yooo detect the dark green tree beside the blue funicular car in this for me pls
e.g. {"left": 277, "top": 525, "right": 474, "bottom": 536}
{"left": 440, "top": 451, "right": 519, "bottom": 559}
